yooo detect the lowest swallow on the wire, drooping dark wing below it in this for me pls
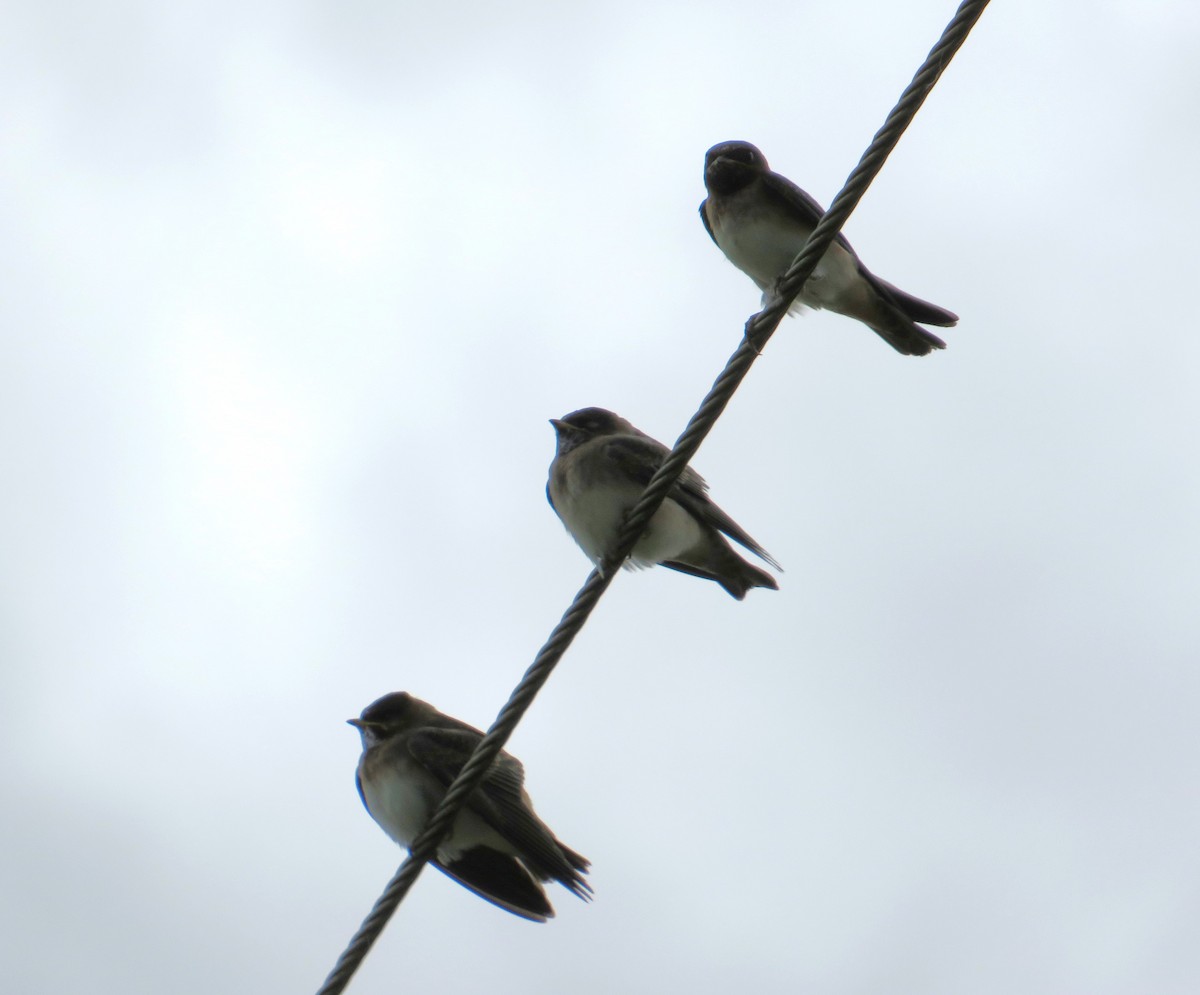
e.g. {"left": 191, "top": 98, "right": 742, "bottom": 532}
{"left": 348, "top": 691, "right": 592, "bottom": 923}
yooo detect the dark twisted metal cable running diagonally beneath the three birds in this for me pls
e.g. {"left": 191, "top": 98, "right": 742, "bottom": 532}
{"left": 318, "top": 0, "right": 988, "bottom": 995}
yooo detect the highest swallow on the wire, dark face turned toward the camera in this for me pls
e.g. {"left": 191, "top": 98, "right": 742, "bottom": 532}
{"left": 700, "top": 142, "right": 959, "bottom": 355}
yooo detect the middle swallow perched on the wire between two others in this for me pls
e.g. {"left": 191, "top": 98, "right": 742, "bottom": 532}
{"left": 546, "top": 408, "right": 782, "bottom": 601}
